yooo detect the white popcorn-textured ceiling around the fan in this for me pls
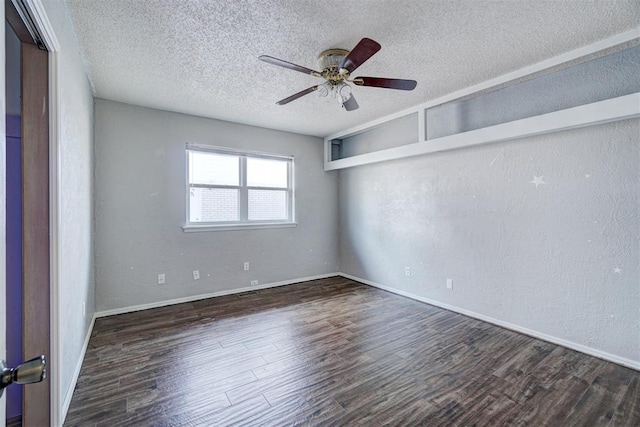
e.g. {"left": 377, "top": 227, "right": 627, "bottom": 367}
{"left": 65, "top": 0, "right": 640, "bottom": 136}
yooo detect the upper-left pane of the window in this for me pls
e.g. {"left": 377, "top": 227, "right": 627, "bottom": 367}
{"left": 189, "top": 151, "right": 240, "bottom": 185}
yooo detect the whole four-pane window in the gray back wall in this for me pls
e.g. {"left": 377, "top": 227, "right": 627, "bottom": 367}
{"left": 185, "top": 144, "right": 294, "bottom": 229}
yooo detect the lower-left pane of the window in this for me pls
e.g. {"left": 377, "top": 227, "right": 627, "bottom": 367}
{"left": 189, "top": 188, "right": 240, "bottom": 222}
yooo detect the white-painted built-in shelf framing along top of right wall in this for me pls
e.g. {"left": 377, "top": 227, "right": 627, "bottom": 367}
{"left": 324, "top": 28, "right": 640, "bottom": 171}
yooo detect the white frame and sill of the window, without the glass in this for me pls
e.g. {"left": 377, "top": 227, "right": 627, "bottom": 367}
{"left": 182, "top": 143, "right": 297, "bottom": 232}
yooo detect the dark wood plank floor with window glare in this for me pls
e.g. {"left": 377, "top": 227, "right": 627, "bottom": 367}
{"left": 65, "top": 277, "right": 640, "bottom": 426}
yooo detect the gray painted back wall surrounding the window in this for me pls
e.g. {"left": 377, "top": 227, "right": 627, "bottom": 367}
{"left": 95, "top": 99, "right": 338, "bottom": 311}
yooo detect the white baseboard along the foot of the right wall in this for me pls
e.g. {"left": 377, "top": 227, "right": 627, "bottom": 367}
{"left": 338, "top": 273, "right": 640, "bottom": 371}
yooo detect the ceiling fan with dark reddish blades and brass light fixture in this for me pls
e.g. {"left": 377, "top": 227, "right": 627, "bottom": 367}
{"left": 258, "top": 38, "right": 417, "bottom": 111}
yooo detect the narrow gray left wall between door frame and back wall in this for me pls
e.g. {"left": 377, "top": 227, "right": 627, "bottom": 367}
{"left": 43, "top": 0, "right": 94, "bottom": 414}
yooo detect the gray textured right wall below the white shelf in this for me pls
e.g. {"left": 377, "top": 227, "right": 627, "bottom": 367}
{"left": 339, "top": 119, "right": 640, "bottom": 362}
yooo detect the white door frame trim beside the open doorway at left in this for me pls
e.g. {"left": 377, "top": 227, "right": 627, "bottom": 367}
{"left": 0, "top": 0, "right": 60, "bottom": 425}
